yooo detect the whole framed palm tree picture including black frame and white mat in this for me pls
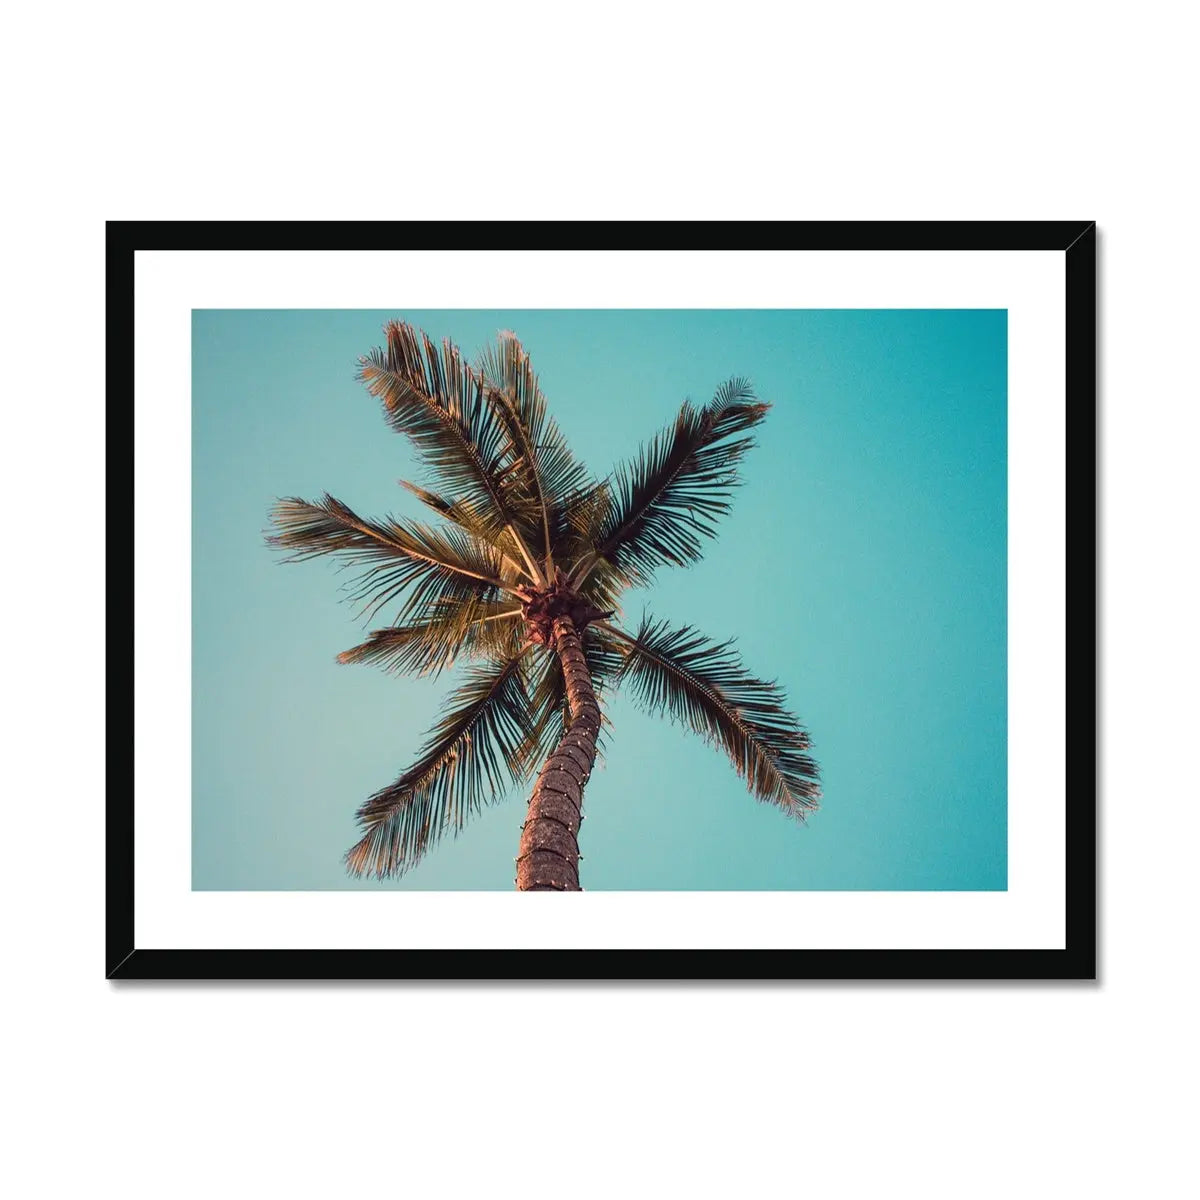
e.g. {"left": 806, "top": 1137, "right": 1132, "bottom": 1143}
{"left": 107, "top": 221, "right": 1096, "bottom": 980}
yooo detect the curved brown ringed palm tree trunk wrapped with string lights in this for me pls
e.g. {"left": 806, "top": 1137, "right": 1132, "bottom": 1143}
{"left": 517, "top": 617, "right": 600, "bottom": 892}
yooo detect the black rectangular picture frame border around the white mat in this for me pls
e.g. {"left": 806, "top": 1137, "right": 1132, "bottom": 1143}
{"left": 106, "top": 221, "right": 1097, "bottom": 980}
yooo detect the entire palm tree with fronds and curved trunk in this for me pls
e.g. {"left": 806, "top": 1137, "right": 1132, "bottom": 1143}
{"left": 269, "top": 322, "right": 820, "bottom": 890}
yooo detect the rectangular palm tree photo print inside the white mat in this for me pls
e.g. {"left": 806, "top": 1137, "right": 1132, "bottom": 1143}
{"left": 192, "top": 310, "right": 1007, "bottom": 890}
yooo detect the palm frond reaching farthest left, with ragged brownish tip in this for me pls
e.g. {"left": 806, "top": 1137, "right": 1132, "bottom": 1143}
{"left": 268, "top": 494, "right": 512, "bottom": 622}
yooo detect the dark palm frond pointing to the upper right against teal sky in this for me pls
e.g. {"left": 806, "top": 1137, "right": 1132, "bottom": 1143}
{"left": 572, "top": 378, "right": 769, "bottom": 583}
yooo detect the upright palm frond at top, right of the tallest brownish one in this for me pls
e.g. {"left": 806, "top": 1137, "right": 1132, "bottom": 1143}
{"left": 476, "top": 331, "right": 588, "bottom": 566}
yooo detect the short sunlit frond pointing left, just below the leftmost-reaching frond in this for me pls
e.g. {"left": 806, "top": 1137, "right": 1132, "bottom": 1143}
{"left": 337, "top": 600, "right": 524, "bottom": 676}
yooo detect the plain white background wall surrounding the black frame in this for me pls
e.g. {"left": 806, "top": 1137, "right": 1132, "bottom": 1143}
{"left": 0, "top": 7, "right": 1200, "bottom": 1198}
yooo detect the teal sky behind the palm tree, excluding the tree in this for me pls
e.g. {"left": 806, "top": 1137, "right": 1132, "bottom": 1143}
{"left": 192, "top": 308, "right": 1007, "bottom": 890}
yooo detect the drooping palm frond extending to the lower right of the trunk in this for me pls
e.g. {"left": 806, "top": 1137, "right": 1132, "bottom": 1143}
{"left": 600, "top": 618, "right": 821, "bottom": 817}
